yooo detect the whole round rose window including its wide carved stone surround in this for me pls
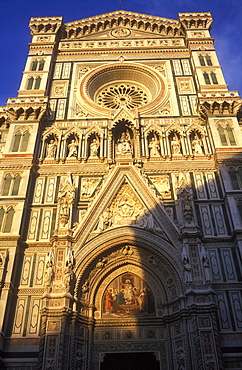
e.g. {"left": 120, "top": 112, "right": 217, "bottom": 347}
{"left": 78, "top": 63, "right": 167, "bottom": 116}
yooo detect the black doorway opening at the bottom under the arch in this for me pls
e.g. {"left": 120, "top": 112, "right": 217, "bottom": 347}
{"left": 100, "top": 352, "right": 160, "bottom": 370}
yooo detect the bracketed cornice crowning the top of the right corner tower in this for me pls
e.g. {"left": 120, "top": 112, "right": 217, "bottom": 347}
{"left": 178, "top": 13, "right": 213, "bottom": 30}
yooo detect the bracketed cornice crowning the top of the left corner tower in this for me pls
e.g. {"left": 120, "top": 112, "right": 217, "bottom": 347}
{"left": 29, "top": 17, "right": 63, "bottom": 35}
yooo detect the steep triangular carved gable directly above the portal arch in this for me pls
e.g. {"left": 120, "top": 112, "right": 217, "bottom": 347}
{"left": 75, "top": 166, "right": 178, "bottom": 249}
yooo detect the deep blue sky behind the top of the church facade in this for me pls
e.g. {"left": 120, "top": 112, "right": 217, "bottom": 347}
{"left": 0, "top": 0, "right": 242, "bottom": 106}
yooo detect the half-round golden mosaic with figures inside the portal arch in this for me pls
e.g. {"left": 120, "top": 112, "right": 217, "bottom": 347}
{"left": 103, "top": 273, "right": 155, "bottom": 318}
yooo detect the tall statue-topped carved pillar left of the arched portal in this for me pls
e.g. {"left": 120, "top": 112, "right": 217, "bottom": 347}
{"left": 38, "top": 177, "right": 75, "bottom": 370}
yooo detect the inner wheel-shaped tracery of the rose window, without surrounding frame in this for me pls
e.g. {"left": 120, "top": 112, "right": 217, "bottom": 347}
{"left": 96, "top": 84, "right": 148, "bottom": 109}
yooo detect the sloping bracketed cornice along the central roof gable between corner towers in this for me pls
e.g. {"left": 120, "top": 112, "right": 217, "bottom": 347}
{"left": 65, "top": 10, "right": 182, "bottom": 38}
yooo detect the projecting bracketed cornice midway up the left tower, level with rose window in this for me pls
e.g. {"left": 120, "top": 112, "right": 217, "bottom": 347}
{"left": 6, "top": 97, "right": 48, "bottom": 121}
